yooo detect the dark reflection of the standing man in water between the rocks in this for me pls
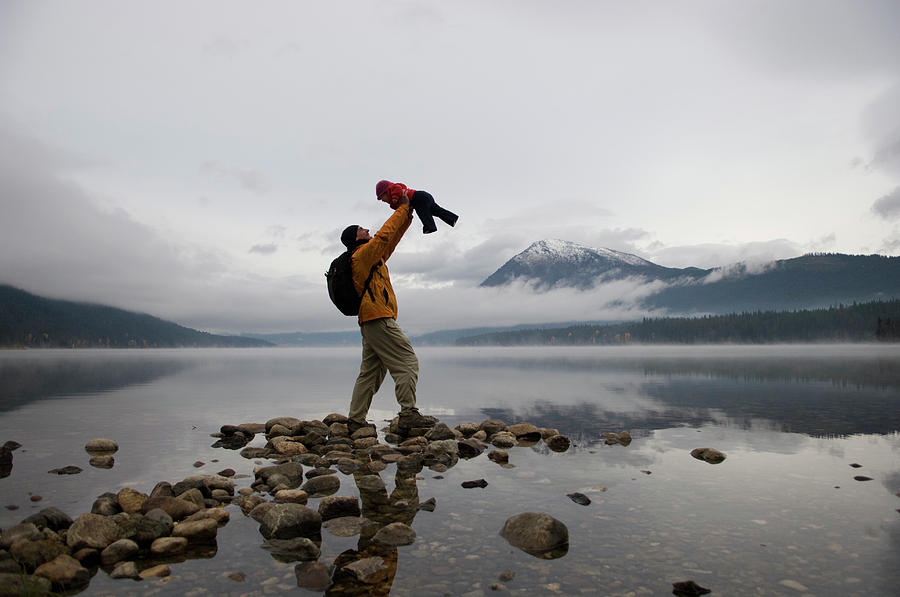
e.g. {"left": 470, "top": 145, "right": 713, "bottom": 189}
{"left": 325, "top": 456, "right": 422, "bottom": 595}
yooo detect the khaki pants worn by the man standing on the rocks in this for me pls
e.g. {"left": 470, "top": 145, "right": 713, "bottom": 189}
{"left": 349, "top": 317, "right": 419, "bottom": 423}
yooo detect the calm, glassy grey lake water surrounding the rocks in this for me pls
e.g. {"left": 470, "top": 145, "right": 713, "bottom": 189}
{"left": 0, "top": 345, "right": 900, "bottom": 596}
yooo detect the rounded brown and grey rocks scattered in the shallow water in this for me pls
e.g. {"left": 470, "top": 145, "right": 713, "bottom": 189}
{"left": 0, "top": 413, "right": 724, "bottom": 597}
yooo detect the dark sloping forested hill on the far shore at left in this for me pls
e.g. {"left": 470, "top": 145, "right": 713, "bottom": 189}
{"left": 0, "top": 285, "right": 271, "bottom": 348}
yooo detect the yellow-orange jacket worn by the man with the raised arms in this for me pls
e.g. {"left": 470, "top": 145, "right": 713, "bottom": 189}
{"left": 350, "top": 205, "right": 412, "bottom": 324}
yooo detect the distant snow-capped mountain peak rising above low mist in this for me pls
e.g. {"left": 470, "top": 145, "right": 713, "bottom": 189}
{"left": 481, "top": 239, "right": 709, "bottom": 289}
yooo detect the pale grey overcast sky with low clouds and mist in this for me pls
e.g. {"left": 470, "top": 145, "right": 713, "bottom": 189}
{"left": 0, "top": 0, "right": 900, "bottom": 333}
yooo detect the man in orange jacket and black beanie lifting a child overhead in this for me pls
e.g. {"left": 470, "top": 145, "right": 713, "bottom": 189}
{"left": 341, "top": 186, "right": 427, "bottom": 433}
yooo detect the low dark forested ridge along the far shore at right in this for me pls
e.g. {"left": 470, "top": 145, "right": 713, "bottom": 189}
{"left": 456, "top": 300, "right": 900, "bottom": 346}
